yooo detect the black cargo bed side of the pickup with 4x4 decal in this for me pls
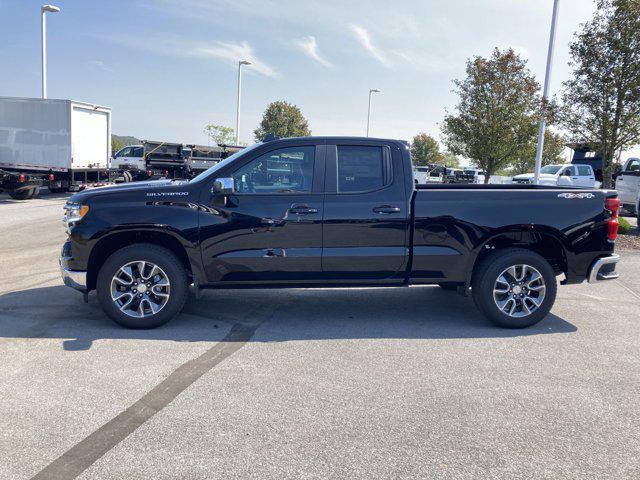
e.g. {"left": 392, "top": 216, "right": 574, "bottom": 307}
{"left": 411, "top": 184, "right": 617, "bottom": 283}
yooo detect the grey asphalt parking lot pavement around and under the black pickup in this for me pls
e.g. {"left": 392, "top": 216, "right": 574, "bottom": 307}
{"left": 0, "top": 193, "right": 640, "bottom": 479}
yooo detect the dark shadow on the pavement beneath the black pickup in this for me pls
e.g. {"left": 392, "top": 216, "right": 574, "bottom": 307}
{"left": 0, "top": 286, "right": 577, "bottom": 351}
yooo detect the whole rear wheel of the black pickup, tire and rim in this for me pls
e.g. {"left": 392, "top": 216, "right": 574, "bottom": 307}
{"left": 471, "top": 248, "right": 558, "bottom": 328}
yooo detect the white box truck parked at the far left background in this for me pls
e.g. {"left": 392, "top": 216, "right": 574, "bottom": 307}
{"left": 0, "top": 97, "right": 111, "bottom": 200}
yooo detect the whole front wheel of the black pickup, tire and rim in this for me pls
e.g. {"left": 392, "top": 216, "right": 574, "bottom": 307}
{"left": 96, "top": 243, "right": 189, "bottom": 329}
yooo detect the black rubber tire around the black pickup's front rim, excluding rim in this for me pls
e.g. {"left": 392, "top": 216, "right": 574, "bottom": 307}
{"left": 96, "top": 244, "right": 189, "bottom": 329}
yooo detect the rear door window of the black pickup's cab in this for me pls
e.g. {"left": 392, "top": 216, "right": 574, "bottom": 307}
{"left": 338, "top": 145, "right": 387, "bottom": 193}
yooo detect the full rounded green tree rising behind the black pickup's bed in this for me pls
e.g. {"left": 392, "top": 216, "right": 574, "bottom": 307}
{"left": 442, "top": 48, "right": 540, "bottom": 183}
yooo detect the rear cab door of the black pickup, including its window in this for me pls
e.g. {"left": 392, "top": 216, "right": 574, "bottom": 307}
{"left": 322, "top": 140, "right": 410, "bottom": 283}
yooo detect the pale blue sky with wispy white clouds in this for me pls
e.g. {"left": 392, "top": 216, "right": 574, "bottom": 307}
{"left": 0, "top": 0, "right": 612, "bottom": 156}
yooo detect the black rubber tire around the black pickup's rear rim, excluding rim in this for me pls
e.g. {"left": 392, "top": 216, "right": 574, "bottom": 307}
{"left": 472, "top": 249, "right": 558, "bottom": 328}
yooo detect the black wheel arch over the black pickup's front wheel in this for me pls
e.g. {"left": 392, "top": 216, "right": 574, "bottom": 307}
{"left": 87, "top": 229, "right": 199, "bottom": 290}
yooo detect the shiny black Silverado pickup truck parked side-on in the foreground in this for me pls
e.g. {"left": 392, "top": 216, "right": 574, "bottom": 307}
{"left": 60, "top": 137, "right": 620, "bottom": 328}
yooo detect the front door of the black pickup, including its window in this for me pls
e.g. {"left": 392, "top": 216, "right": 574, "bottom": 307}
{"left": 200, "top": 143, "right": 325, "bottom": 284}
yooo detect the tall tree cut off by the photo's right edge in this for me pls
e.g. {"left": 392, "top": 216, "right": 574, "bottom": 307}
{"left": 561, "top": 0, "right": 640, "bottom": 188}
